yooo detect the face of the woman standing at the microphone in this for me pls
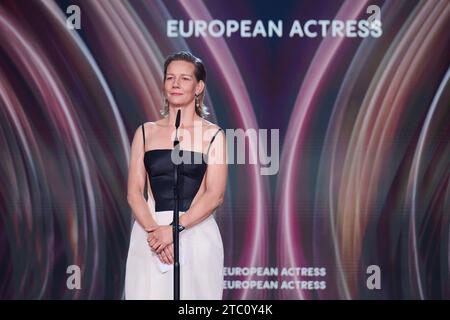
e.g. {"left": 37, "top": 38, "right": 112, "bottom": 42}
{"left": 164, "top": 61, "right": 204, "bottom": 106}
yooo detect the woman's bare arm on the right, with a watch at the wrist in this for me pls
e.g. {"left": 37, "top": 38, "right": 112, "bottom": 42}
{"left": 179, "top": 131, "right": 228, "bottom": 229}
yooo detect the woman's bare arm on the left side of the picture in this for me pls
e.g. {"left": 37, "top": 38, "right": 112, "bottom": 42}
{"left": 127, "top": 126, "right": 157, "bottom": 230}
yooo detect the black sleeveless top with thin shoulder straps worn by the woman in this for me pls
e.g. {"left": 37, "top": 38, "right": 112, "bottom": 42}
{"left": 142, "top": 124, "right": 222, "bottom": 211}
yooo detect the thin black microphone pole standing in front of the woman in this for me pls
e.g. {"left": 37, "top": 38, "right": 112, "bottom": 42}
{"left": 172, "top": 109, "right": 181, "bottom": 300}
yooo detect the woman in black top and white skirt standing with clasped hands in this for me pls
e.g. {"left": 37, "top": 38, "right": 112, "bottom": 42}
{"left": 125, "top": 51, "right": 227, "bottom": 300}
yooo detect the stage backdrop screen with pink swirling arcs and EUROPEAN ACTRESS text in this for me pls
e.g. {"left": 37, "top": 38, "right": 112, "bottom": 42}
{"left": 0, "top": 0, "right": 450, "bottom": 299}
